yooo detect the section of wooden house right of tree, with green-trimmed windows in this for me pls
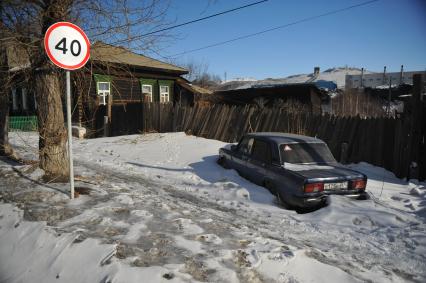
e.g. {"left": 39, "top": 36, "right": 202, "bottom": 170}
{"left": 73, "top": 42, "right": 206, "bottom": 128}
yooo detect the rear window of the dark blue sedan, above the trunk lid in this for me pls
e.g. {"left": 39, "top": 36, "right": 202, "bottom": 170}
{"left": 280, "top": 143, "right": 336, "bottom": 163}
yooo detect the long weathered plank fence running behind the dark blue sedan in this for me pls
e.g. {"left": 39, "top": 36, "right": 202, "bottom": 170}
{"left": 96, "top": 103, "right": 426, "bottom": 179}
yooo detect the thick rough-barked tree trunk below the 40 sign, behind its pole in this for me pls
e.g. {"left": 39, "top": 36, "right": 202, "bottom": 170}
{"left": 34, "top": 69, "right": 69, "bottom": 181}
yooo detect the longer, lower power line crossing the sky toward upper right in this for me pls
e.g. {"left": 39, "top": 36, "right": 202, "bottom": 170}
{"left": 168, "top": 0, "right": 379, "bottom": 58}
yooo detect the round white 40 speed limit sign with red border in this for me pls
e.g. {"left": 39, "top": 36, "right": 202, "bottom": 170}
{"left": 44, "top": 22, "right": 90, "bottom": 70}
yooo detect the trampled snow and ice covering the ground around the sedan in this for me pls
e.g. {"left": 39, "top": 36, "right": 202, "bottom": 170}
{"left": 0, "top": 133, "right": 426, "bottom": 282}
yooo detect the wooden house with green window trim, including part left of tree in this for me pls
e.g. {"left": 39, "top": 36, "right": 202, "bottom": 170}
{"left": 8, "top": 42, "right": 206, "bottom": 133}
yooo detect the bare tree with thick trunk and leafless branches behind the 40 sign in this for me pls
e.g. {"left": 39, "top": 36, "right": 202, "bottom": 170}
{"left": 0, "top": 0, "right": 173, "bottom": 180}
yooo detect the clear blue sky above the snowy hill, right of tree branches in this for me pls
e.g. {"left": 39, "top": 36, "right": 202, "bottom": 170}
{"left": 156, "top": 0, "right": 426, "bottom": 80}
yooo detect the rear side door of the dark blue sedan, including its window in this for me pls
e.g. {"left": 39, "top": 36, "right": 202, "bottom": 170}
{"left": 247, "top": 138, "right": 272, "bottom": 185}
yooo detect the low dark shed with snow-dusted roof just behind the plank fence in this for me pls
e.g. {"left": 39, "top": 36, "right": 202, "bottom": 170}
{"left": 203, "top": 83, "right": 330, "bottom": 113}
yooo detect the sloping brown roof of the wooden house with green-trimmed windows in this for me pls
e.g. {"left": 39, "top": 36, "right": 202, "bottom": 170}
{"left": 90, "top": 41, "right": 188, "bottom": 75}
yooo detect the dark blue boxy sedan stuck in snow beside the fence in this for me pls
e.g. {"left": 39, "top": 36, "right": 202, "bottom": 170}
{"left": 218, "top": 133, "right": 367, "bottom": 208}
